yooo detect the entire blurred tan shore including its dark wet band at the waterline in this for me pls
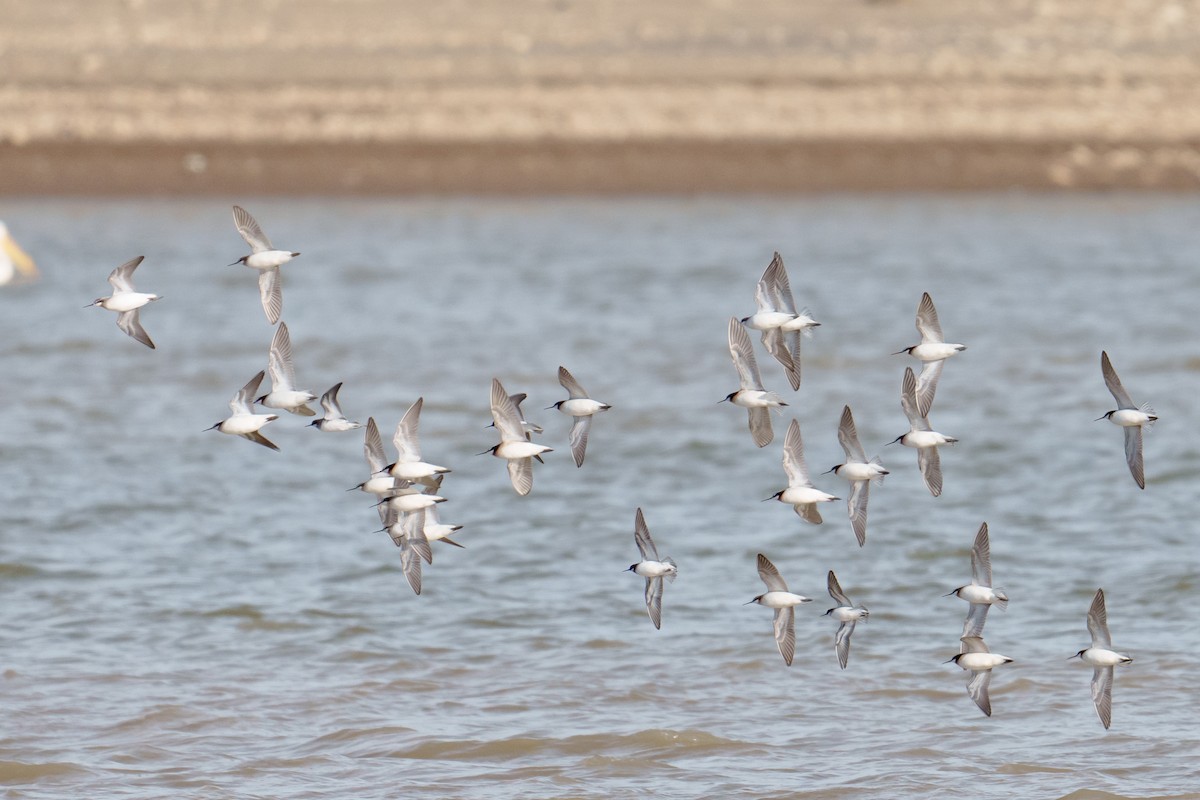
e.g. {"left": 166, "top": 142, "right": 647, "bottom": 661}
{"left": 0, "top": 0, "right": 1200, "bottom": 194}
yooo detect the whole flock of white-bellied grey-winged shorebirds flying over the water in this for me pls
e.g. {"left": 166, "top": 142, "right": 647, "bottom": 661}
{"left": 79, "top": 214, "right": 1157, "bottom": 728}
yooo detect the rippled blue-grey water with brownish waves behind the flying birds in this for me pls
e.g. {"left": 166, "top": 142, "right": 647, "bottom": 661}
{"left": 0, "top": 194, "right": 1200, "bottom": 799}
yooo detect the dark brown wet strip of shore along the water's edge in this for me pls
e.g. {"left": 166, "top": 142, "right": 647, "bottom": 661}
{"left": 7, "top": 139, "right": 1200, "bottom": 196}
